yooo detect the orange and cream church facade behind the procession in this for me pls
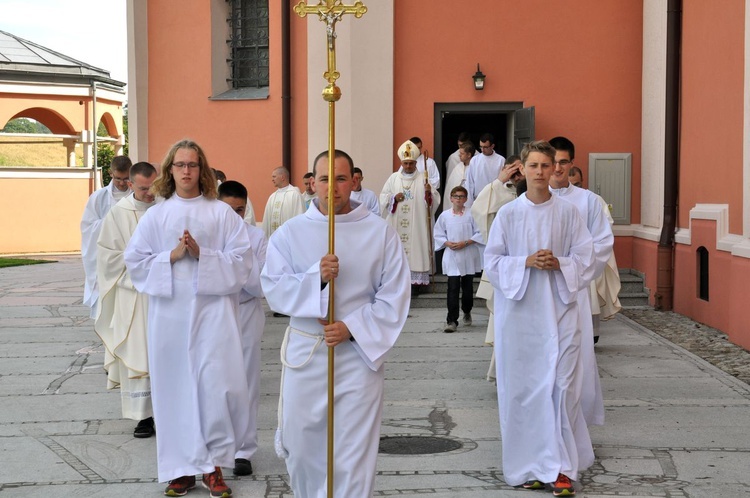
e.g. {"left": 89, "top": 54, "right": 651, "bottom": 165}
{"left": 128, "top": 0, "right": 750, "bottom": 348}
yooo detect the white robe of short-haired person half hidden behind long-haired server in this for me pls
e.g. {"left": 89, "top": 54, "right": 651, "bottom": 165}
{"left": 235, "top": 224, "right": 268, "bottom": 460}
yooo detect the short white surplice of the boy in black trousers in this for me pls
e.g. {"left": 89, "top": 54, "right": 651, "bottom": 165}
{"left": 435, "top": 209, "right": 484, "bottom": 277}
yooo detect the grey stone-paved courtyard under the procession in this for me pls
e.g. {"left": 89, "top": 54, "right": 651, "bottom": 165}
{"left": 0, "top": 256, "right": 750, "bottom": 498}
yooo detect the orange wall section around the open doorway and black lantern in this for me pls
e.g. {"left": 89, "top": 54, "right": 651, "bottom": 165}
{"left": 394, "top": 0, "right": 643, "bottom": 223}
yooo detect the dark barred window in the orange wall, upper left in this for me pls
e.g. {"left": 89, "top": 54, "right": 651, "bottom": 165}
{"left": 227, "top": 0, "right": 268, "bottom": 89}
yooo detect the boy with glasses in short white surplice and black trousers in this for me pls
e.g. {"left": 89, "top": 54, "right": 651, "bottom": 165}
{"left": 435, "top": 186, "right": 483, "bottom": 333}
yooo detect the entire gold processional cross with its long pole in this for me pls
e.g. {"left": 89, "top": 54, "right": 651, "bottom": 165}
{"left": 294, "top": 0, "right": 367, "bottom": 498}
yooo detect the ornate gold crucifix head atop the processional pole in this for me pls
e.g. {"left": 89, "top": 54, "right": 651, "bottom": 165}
{"left": 294, "top": 0, "right": 367, "bottom": 102}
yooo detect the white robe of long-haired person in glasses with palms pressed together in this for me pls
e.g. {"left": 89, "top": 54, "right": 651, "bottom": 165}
{"left": 125, "top": 195, "right": 251, "bottom": 482}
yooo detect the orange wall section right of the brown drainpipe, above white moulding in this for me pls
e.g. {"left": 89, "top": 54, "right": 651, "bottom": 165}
{"left": 679, "top": 0, "right": 745, "bottom": 234}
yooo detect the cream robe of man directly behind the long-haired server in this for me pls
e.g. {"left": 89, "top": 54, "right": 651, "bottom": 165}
{"left": 94, "top": 194, "right": 153, "bottom": 420}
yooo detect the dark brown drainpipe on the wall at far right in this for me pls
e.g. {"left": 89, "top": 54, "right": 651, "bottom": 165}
{"left": 654, "top": 0, "right": 682, "bottom": 311}
